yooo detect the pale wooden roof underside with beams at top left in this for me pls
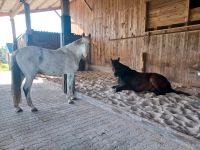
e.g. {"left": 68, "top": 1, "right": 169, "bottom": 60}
{"left": 0, "top": 0, "right": 61, "bottom": 16}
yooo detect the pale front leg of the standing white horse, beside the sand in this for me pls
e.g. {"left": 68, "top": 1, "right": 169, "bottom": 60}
{"left": 67, "top": 73, "right": 75, "bottom": 104}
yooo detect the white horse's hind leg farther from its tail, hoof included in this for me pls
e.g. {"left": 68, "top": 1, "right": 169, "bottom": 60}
{"left": 23, "top": 77, "right": 38, "bottom": 112}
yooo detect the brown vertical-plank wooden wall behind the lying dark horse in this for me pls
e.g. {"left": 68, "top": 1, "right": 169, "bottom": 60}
{"left": 70, "top": 0, "right": 200, "bottom": 86}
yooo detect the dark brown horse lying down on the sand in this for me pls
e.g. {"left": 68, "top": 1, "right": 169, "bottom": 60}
{"left": 111, "top": 58, "right": 189, "bottom": 96}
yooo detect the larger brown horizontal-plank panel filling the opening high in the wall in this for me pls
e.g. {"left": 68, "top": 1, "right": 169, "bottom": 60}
{"left": 147, "top": 0, "right": 187, "bottom": 28}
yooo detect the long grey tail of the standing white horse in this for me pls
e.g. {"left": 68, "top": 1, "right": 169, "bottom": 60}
{"left": 11, "top": 53, "right": 24, "bottom": 107}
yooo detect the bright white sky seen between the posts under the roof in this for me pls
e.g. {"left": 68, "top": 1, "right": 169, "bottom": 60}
{"left": 0, "top": 11, "right": 61, "bottom": 46}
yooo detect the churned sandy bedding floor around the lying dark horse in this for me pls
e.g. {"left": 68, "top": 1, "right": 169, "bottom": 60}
{"left": 38, "top": 71, "right": 200, "bottom": 139}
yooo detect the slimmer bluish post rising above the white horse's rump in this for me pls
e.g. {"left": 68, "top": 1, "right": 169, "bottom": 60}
{"left": 21, "top": 0, "right": 32, "bottom": 46}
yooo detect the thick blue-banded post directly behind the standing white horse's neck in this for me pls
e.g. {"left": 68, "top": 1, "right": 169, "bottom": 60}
{"left": 60, "top": 0, "right": 75, "bottom": 93}
